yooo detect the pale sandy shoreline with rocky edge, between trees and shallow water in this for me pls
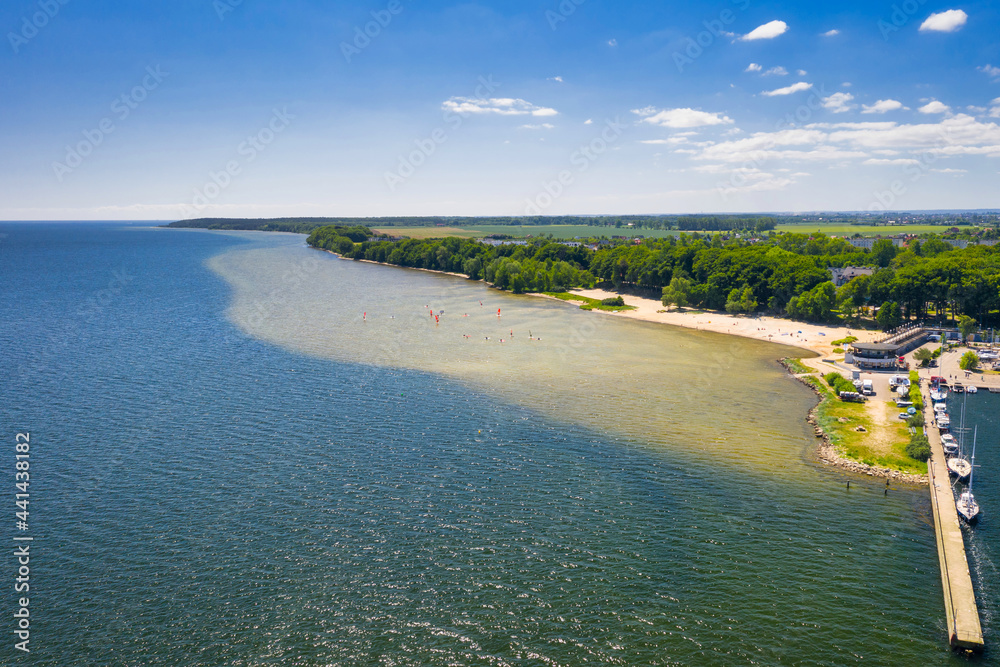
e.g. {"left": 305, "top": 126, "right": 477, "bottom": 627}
{"left": 315, "top": 248, "right": 927, "bottom": 485}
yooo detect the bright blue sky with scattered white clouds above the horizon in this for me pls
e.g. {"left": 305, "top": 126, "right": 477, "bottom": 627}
{"left": 0, "top": 0, "right": 1000, "bottom": 220}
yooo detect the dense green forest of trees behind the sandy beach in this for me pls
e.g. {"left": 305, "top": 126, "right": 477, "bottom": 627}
{"left": 309, "top": 228, "right": 1000, "bottom": 329}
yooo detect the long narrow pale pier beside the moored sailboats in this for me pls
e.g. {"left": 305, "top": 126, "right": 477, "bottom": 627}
{"left": 921, "top": 386, "right": 984, "bottom": 651}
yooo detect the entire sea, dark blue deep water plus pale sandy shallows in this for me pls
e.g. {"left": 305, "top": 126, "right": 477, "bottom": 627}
{"left": 0, "top": 223, "right": 984, "bottom": 665}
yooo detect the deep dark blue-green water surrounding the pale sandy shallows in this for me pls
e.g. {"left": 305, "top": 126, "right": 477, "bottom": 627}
{"left": 0, "top": 224, "right": 1000, "bottom": 665}
